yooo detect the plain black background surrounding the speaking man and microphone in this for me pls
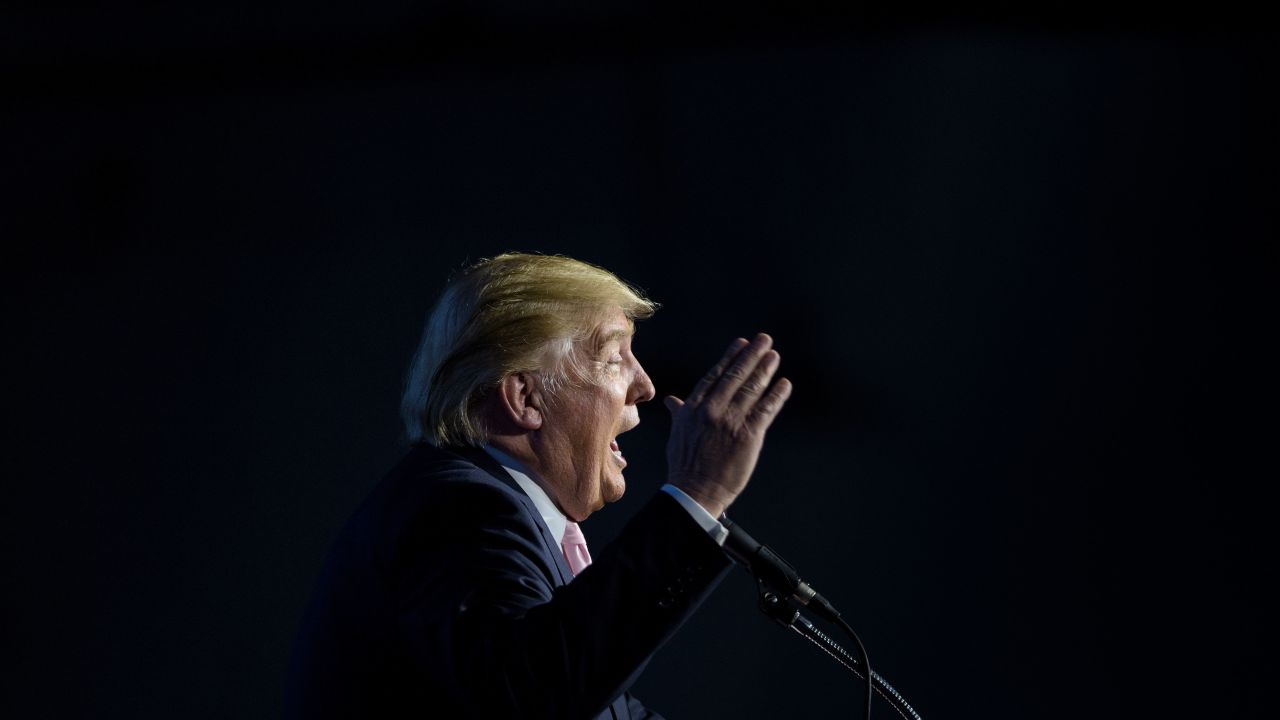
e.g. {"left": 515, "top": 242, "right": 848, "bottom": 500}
{"left": 0, "top": 0, "right": 1277, "bottom": 719}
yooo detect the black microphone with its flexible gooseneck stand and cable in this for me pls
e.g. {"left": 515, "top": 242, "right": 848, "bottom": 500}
{"left": 721, "top": 516, "right": 923, "bottom": 720}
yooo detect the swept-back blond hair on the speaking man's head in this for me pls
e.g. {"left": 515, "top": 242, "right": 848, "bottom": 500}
{"left": 401, "top": 252, "right": 658, "bottom": 446}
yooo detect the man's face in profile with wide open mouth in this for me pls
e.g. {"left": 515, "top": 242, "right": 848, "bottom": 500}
{"left": 539, "top": 309, "right": 654, "bottom": 521}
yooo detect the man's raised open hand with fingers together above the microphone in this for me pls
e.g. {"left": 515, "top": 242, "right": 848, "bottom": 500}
{"left": 664, "top": 333, "right": 791, "bottom": 518}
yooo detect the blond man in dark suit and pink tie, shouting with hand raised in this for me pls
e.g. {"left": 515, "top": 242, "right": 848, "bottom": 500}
{"left": 287, "top": 254, "right": 791, "bottom": 719}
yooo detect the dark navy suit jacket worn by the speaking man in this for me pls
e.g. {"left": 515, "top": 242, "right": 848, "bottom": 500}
{"left": 285, "top": 446, "right": 728, "bottom": 719}
